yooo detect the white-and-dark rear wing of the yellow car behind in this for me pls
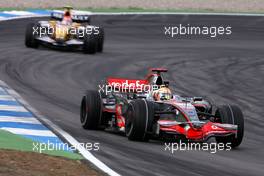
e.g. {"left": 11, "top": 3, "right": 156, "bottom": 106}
{"left": 50, "top": 10, "right": 91, "bottom": 23}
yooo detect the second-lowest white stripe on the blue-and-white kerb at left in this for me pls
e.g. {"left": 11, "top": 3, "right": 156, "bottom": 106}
{"left": 0, "top": 116, "right": 41, "bottom": 124}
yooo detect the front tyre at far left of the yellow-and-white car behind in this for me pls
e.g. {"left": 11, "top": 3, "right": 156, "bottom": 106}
{"left": 25, "top": 23, "right": 40, "bottom": 48}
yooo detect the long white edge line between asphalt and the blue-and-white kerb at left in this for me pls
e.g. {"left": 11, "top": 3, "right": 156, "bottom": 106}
{"left": 0, "top": 80, "right": 120, "bottom": 176}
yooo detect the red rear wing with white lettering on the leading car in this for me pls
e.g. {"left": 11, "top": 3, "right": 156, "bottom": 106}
{"left": 107, "top": 78, "right": 149, "bottom": 93}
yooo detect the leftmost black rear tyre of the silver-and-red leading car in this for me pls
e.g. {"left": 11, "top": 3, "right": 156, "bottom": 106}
{"left": 80, "top": 90, "right": 102, "bottom": 129}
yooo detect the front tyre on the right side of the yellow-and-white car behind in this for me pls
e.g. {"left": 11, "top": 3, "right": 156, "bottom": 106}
{"left": 83, "top": 28, "right": 98, "bottom": 54}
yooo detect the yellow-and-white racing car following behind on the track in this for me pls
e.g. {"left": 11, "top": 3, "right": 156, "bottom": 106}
{"left": 25, "top": 7, "right": 104, "bottom": 54}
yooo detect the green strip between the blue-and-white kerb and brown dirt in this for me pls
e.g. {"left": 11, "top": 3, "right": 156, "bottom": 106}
{"left": 0, "top": 130, "right": 83, "bottom": 160}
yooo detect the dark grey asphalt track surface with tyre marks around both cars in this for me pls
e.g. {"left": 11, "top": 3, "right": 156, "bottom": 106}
{"left": 0, "top": 15, "right": 264, "bottom": 176}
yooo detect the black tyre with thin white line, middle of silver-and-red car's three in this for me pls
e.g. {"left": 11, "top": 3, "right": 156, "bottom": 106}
{"left": 125, "top": 99, "right": 154, "bottom": 141}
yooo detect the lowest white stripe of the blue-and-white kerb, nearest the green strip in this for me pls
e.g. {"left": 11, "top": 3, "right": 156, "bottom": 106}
{"left": 0, "top": 127, "right": 57, "bottom": 137}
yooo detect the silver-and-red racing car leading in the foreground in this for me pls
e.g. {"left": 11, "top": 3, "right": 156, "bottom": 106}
{"left": 80, "top": 68, "right": 244, "bottom": 147}
